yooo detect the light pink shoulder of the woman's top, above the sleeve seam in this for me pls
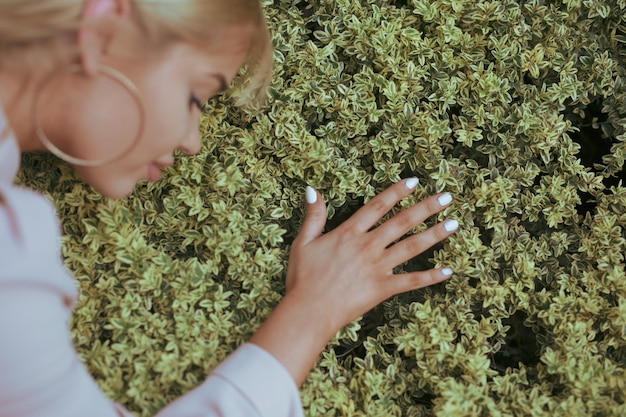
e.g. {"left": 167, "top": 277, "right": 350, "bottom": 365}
{"left": 0, "top": 182, "right": 76, "bottom": 299}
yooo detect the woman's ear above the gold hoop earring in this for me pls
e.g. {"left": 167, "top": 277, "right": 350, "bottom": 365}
{"left": 78, "top": 0, "right": 132, "bottom": 75}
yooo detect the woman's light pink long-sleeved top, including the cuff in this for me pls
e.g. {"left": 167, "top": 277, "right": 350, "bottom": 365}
{"left": 0, "top": 111, "right": 303, "bottom": 417}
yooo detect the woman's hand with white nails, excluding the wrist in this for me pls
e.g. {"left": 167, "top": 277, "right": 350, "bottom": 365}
{"left": 287, "top": 178, "right": 458, "bottom": 332}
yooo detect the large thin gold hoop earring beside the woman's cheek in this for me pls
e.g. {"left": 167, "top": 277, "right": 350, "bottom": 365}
{"left": 33, "top": 64, "right": 146, "bottom": 167}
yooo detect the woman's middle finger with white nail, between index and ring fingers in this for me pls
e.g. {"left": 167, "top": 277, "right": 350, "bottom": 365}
{"left": 371, "top": 193, "right": 452, "bottom": 246}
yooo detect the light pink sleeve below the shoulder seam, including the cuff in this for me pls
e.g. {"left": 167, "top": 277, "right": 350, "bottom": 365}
{"left": 0, "top": 286, "right": 303, "bottom": 417}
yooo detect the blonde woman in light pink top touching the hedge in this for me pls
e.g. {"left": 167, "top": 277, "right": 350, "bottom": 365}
{"left": 0, "top": 0, "right": 458, "bottom": 417}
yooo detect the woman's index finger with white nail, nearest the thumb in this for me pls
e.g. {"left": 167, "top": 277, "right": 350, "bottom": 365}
{"left": 344, "top": 178, "right": 419, "bottom": 232}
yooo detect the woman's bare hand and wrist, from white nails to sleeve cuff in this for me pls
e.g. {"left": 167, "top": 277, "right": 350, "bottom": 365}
{"left": 251, "top": 178, "right": 458, "bottom": 384}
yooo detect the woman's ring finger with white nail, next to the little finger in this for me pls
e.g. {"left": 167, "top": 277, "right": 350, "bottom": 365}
{"left": 378, "top": 219, "right": 459, "bottom": 269}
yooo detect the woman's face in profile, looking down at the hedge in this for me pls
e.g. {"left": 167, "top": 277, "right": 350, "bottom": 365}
{"left": 48, "top": 30, "right": 248, "bottom": 198}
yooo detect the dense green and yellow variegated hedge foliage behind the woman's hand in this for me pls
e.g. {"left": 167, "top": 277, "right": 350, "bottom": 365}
{"left": 17, "top": 0, "right": 626, "bottom": 417}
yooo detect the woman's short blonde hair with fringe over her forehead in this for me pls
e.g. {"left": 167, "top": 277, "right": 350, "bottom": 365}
{"left": 0, "top": 0, "right": 272, "bottom": 106}
